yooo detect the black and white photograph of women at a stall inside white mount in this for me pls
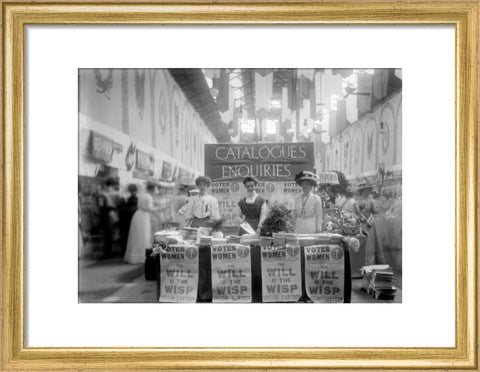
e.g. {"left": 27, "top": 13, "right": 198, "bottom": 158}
{"left": 78, "top": 67, "right": 402, "bottom": 304}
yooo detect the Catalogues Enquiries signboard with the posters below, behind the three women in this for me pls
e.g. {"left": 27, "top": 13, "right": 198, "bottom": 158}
{"left": 205, "top": 142, "right": 315, "bottom": 226}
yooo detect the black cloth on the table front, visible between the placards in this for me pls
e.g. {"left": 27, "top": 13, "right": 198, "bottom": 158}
{"left": 154, "top": 237, "right": 352, "bottom": 303}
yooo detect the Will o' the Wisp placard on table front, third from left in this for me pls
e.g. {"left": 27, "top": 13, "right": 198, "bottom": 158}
{"left": 261, "top": 245, "right": 302, "bottom": 302}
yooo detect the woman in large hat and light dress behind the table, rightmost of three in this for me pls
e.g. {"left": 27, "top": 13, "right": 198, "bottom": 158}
{"left": 293, "top": 171, "right": 323, "bottom": 234}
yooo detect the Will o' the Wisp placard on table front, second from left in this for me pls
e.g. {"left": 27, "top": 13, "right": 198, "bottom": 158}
{"left": 210, "top": 244, "right": 252, "bottom": 302}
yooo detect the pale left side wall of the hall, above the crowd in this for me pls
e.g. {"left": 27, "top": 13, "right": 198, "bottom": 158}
{"left": 79, "top": 69, "right": 216, "bottom": 186}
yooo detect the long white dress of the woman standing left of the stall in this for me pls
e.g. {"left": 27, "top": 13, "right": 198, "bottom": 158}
{"left": 123, "top": 193, "right": 153, "bottom": 264}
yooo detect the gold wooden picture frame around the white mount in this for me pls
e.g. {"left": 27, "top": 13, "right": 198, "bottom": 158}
{"left": 1, "top": 0, "right": 479, "bottom": 370}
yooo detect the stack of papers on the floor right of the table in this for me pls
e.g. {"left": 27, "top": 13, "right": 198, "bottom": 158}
{"left": 361, "top": 265, "right": 397, "bottom": 300}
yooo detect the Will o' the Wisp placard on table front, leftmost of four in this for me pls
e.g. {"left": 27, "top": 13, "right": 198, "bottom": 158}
{"left": 159, "top": 244, "right": 198, "bottom": 302}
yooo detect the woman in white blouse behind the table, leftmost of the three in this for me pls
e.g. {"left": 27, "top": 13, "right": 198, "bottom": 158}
{"left": 185, "top": 176, "right": 220, "bottom": 227}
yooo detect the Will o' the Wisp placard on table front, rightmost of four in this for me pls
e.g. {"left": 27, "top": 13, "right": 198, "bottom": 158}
{"left": 304, "top": 244, "right": 345, "bottom": 302}
